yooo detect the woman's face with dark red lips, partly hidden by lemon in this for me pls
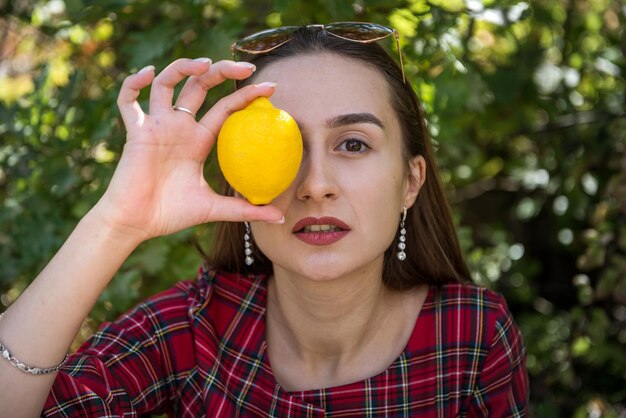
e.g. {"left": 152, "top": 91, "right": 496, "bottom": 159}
{"left": 251, "top": 53, "right": 424, "bottom": 280}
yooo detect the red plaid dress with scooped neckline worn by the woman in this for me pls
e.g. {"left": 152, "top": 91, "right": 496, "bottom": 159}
{"left": 43, "top": 270, "right": 528, "bottom": 418}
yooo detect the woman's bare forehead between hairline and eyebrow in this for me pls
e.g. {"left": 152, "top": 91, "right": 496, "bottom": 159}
{"left": 254, "top": 53, "right": 395, "bottom": 126}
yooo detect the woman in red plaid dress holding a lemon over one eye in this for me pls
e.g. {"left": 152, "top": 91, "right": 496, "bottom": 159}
{"left": 0, "top": 24, "right": 527, "bottom": 417}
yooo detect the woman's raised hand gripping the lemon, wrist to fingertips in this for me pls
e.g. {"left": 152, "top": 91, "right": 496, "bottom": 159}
{"left": 94, "top": 59, "right": 282, "bottom": 240}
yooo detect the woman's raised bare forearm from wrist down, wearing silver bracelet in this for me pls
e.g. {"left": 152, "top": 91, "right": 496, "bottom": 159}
{"left": 0, "top": 210, "right": 139, "bottom": 417}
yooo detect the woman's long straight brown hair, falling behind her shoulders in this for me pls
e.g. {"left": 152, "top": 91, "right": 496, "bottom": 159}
{"left": 207, "top": 27, "right": 469, "bottom": 290}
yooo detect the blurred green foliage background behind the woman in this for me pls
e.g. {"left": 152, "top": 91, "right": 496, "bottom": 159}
{"left": 0, "top": 0, "right": 626, "bottom": 417}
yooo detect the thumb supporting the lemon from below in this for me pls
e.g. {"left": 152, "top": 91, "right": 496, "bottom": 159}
{"left": 206, "top": 195, "right": 285, "bottom": 223}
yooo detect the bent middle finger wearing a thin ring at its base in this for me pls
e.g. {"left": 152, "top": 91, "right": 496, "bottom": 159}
{"left": 176, "top": 61, "right": 256, "bottom": 112}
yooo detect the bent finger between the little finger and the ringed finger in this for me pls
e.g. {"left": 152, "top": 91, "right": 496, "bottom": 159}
{"left": 150, "top": 58, "right": 211, "bottom": 113}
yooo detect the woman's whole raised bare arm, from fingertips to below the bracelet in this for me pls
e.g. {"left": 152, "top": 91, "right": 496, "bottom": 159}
{"left": 0, "top": 60, "right": 281, "bottom": 418}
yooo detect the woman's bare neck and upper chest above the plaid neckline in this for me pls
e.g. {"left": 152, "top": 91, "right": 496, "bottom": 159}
{"left": 267, "top": 260, "right": 425, "bottom": 390}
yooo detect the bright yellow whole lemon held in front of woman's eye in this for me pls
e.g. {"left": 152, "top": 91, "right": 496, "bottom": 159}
{"left": 217, "top": 97, "right": 302, "bottom": 205}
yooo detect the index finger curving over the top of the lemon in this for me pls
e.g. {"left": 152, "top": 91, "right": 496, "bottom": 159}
{"left": 198, "top": 82, "right": 276, "bottom": 140}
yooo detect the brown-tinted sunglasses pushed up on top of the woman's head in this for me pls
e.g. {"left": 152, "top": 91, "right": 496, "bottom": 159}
{"left": 230, "top": 22, "right": 406, "bottom": 83}
